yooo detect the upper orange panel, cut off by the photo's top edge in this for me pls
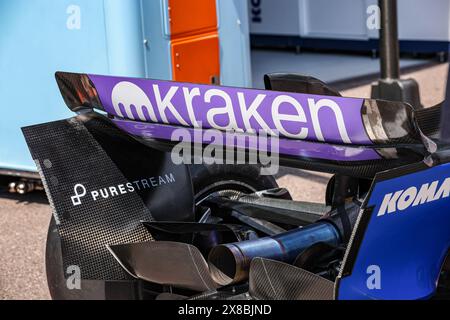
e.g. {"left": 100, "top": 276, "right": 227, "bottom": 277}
{"left": 169, "top": 0, "right": 217, "bottom": 39}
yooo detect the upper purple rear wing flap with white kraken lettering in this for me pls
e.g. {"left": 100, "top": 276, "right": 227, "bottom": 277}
{"left": 56, "top": 72, "right": 430, "bottom": 151}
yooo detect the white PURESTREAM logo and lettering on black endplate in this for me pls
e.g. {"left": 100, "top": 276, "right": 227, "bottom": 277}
{"left": 70, "top": 173, "right": 176, "bottom": 206}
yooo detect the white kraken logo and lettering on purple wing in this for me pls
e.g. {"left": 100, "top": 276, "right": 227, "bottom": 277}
{"left": 106, "top": 80, "right": 354, "bottom": 144}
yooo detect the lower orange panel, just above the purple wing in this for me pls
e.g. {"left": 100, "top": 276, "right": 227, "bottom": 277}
{"left": 172, "top": 33, "right": 220, "bottom": 84}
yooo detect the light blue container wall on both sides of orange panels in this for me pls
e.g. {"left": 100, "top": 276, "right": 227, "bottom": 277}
{"left": 0, "top": 0, "right": 250, "bottom": 174}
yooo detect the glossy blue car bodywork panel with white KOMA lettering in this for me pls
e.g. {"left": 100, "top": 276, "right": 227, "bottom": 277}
{"left": 337, "top": 163, "right": 450, "bottom": 300}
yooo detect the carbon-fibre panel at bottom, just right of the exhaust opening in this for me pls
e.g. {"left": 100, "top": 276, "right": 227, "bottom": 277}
{"left": 249, "top": 258, "right": 334, "bottom": 300}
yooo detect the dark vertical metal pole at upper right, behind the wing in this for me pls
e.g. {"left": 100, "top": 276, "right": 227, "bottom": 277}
{"left": 379, "top": 0, "right": 400, "bottom": 79}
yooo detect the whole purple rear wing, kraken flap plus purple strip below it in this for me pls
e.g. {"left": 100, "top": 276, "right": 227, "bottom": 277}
{"left": 56, "top": 72, "right": 434, "bottom": 174}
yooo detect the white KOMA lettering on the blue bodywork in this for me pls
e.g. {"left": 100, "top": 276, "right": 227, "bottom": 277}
{"left": 377, "top": 178, "right": 450, "bottom": 217}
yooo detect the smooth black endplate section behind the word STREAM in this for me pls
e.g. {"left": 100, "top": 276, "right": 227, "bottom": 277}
{"left": 78, "top": 113, "right": 195, "bottom": 221}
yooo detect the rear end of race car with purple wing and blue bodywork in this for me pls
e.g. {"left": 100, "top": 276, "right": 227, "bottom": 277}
{"left": 23, "top": 73, "right": 450, "bottom": 300}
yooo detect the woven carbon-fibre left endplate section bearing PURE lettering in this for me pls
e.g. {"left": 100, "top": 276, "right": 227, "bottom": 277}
{"left": 23, "top": 118, "right": 153, "bottom": 280}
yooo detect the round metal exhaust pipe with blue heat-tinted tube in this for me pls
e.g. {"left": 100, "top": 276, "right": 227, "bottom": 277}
{"left": 208, "top": 203, "right": 360, "bottom": 286}
